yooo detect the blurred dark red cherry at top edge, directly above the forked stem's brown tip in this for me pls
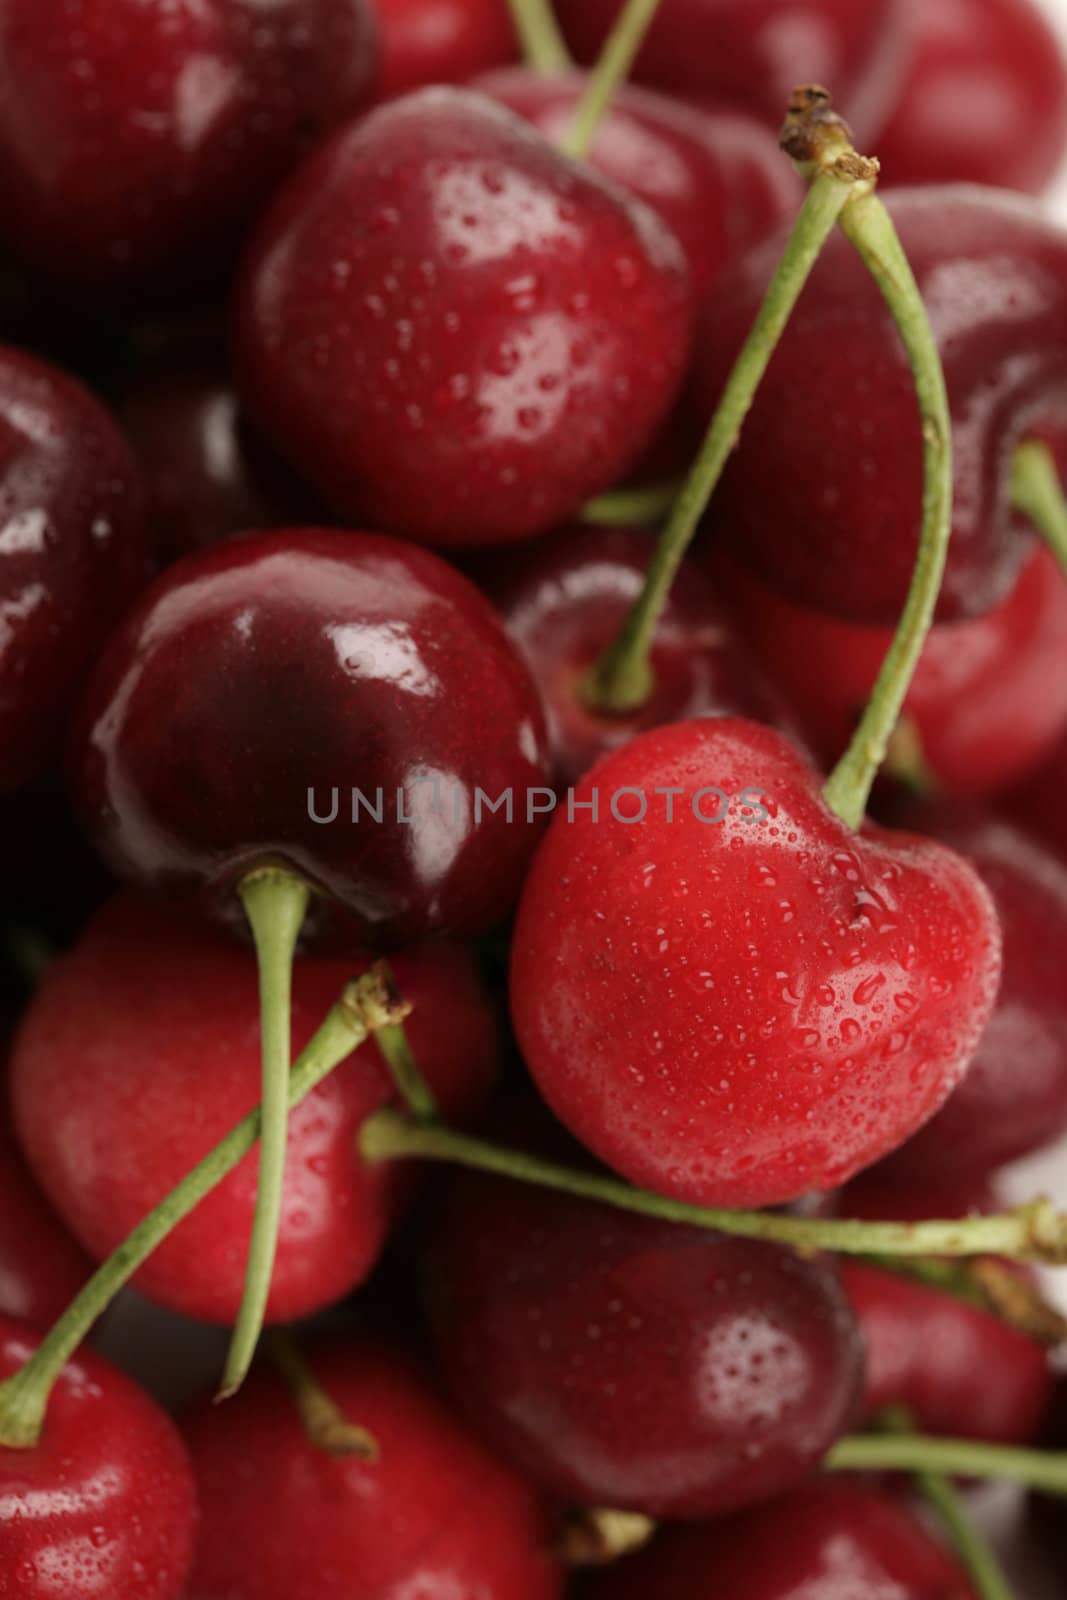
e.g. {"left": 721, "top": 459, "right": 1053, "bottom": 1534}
{"left": 557, "top": 0, "right": 909, "bottom": 139}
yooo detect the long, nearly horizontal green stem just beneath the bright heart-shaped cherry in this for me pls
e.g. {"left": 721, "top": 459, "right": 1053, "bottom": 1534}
{"left": 360, "top": 1109, "right": 1067, "bottom": 1264}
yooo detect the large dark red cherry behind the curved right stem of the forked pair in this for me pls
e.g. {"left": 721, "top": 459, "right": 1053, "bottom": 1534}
{"left": 694, "top": 189, "right": 1067, "bottom": 624}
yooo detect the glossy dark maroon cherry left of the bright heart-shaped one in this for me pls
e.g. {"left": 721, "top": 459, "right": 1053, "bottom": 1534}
{"left": 72, "top": 528, "right": 545, "bottom": 941}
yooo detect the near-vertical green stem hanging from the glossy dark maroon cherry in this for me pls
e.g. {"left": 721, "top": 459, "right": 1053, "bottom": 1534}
{"left": 219, "top": 867, "right": 310, "bottom": 1397}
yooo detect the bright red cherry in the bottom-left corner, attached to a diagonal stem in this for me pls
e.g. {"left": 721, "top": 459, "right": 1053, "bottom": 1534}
{"left": 0, "top": 1318, "right": 197, "bottom": 1600}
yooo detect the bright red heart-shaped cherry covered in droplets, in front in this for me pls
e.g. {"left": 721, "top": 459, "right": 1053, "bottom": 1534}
{"left": 510, "top": 717, "right": 1000, "bottom": 1205}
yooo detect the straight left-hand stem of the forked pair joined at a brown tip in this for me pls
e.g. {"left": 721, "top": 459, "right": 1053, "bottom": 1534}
{"left": 584, "top": 152, "right": 862, "bottom": 712}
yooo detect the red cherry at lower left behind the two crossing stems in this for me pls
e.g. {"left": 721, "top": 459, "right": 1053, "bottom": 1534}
{"left": 11, "top": 898, "right": 496, "bottom": 1322}
